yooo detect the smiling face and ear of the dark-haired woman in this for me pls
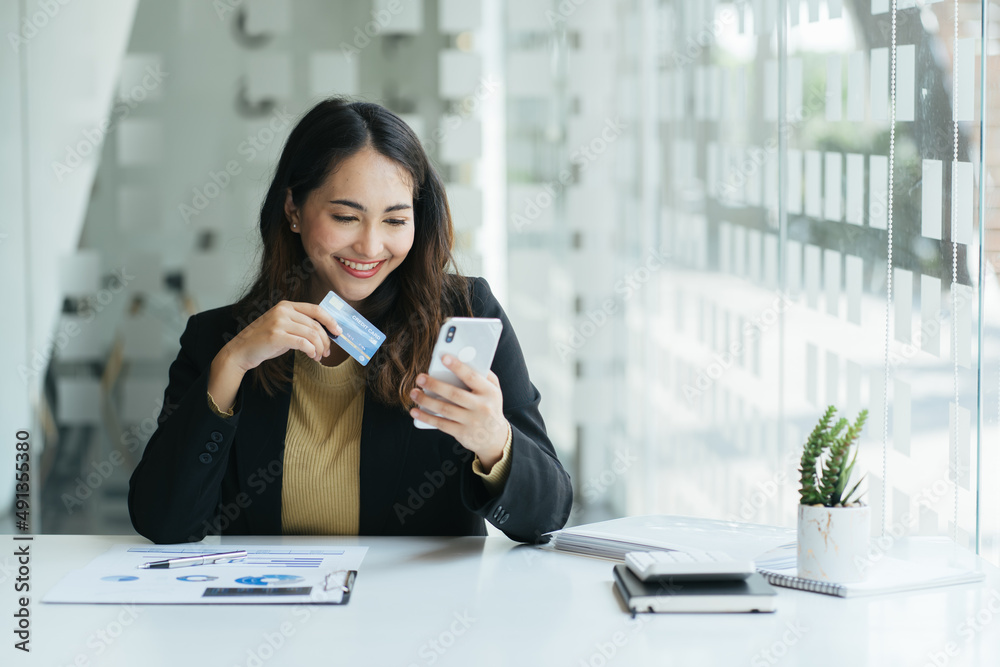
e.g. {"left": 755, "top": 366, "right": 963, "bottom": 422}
{"left": 285, "top": 148, "right": 414, "bottom": 308}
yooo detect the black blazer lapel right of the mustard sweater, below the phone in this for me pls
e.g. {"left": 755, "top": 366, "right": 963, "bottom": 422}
{"left": 358, "top": 389, "right": 413, "bottom": 535}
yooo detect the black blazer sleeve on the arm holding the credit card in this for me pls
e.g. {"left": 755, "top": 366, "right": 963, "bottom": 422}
{"left": 128, "top": 315, "right": 243, "bottom": 544}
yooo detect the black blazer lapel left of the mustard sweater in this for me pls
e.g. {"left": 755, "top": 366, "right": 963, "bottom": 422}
{"left": 234, "top": 379, "right": 292, "bottom": 535}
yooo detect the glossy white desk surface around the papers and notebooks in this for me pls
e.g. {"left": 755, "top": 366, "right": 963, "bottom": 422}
{"left": 0, "top": 536, "right": 1000, "bottom": 667}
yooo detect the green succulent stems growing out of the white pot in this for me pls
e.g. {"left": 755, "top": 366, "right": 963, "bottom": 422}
{"left": 799, "top": 405, "right": 868, "bottom": 507}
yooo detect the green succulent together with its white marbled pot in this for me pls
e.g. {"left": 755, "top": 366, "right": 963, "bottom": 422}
{"left": 798, "top": 405, "right": 871, "bottom": 583}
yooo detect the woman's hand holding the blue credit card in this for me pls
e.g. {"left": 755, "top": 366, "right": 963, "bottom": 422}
{"left": 223, "top": 301, "right": 343, "bottom": 373}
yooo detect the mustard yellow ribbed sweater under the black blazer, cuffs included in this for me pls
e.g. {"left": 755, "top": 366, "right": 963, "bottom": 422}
{"left": 208, "top": 350, "right": 511, "bottom": 535}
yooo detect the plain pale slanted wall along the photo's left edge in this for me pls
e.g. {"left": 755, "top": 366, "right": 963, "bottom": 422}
{"left": 0, "top": 0, "right": 137, "bottom": 518}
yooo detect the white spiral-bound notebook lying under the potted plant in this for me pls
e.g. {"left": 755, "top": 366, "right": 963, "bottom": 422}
{"left": 757, "top": 556, "right": 986, "bottom": 598}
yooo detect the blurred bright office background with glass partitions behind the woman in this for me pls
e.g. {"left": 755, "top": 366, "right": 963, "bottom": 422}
{"left": 0, "top": 0, "right": 1000, "bottom": 563}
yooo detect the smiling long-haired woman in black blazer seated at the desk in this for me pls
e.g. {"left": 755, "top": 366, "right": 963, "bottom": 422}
{"left": 129, "top": 99, "right": 572, "bottom": 542}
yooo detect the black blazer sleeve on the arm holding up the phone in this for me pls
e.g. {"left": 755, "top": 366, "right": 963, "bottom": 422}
{"left": 461, "top": 278, "right": 573, "bottom": 542}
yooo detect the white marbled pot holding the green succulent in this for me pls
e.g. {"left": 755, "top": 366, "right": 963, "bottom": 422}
{"left": 798, "top": 505, "right": 871, "bottom": 584}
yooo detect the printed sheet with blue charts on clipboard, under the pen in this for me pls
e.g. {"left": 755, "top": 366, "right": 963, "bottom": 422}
{"left": 42, "top": 544, "right": 368, "bottom": 604}
